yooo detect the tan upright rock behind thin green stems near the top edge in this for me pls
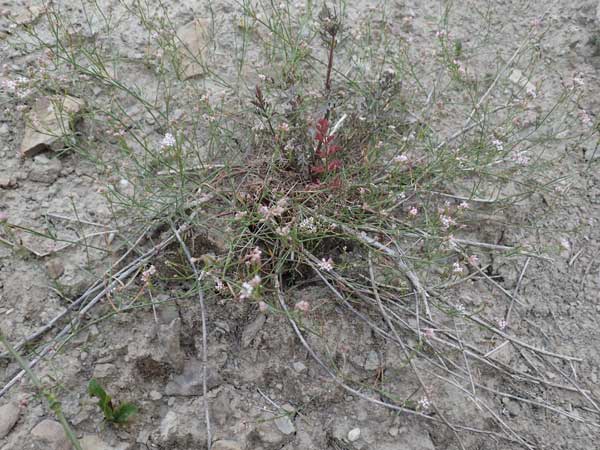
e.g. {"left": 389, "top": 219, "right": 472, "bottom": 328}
{"left": 177, "top": 19, "right": 210, "bottom": 80}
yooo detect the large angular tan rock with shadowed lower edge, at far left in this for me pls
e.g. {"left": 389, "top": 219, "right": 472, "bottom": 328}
{"left": 21, "top": 96, "right": 84, "bottom": 157}
